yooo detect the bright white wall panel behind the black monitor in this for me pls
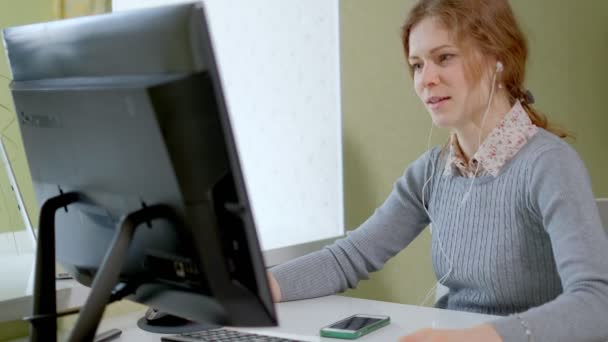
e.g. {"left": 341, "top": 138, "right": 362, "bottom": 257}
{"left": 113, "top": 0, "right": 344, "bottom": 256}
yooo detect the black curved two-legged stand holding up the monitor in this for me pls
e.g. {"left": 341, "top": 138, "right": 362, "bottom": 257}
{"left": 24, "top": 192, "right": 200, "bottom": 342}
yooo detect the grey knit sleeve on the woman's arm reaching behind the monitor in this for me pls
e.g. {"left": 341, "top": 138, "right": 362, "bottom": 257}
{"left": 270, "top": 150, "right": 438, "bottom": 301}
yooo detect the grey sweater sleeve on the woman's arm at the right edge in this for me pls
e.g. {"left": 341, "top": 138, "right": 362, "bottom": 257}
{"left": 492, "top": 145, "right": 608, "bottom": 342}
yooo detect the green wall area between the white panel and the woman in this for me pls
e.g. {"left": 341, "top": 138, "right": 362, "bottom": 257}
{"left": 340, "top": 0, "right": 446, "bottom": 304}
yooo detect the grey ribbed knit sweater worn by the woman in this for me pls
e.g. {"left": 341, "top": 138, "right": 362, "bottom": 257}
{"left": 271, "top": 129, "right": 608, "bottom": 342}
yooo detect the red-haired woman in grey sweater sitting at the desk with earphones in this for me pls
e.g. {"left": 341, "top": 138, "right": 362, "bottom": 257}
{"left": 270, "top": 0, "right": 608, "bottom": 342}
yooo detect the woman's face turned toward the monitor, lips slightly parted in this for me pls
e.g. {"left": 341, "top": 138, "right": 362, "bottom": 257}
{"left": 408, "top": 17, "right": 490, "bottom": 129}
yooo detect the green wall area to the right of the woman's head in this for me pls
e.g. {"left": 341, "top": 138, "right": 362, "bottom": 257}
{"left": 511, "top": 0, "right": 608, "bottom": 197}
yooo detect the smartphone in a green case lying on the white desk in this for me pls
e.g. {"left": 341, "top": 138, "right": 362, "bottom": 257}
{"left": 321, "top": 314, "right": 391, "bottom": 340}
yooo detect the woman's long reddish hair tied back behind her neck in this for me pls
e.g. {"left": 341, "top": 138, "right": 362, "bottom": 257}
{"left": 401, "top": 0, "right": 570, "bottom": 138}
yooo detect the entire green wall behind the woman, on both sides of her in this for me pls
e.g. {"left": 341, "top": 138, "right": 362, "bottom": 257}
{"left": 340, "top": 0, "right": 608, "bottom": 304}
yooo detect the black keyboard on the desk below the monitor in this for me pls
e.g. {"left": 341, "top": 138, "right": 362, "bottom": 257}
{"left": 161, "top": 328, "right": 303, "bottom": 342}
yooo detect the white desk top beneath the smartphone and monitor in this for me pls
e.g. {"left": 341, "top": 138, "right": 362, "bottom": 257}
{"left": 92, "top": 296, "right": 496, "bottom": 342}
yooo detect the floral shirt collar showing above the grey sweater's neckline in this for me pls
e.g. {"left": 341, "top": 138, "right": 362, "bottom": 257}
{"left": 444, "top": 101, "right": 538, "bottom": 178}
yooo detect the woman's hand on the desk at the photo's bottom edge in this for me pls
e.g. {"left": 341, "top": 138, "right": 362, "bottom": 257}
{"left": 399, "top": 324, "right": 502, "bottom": 342}
